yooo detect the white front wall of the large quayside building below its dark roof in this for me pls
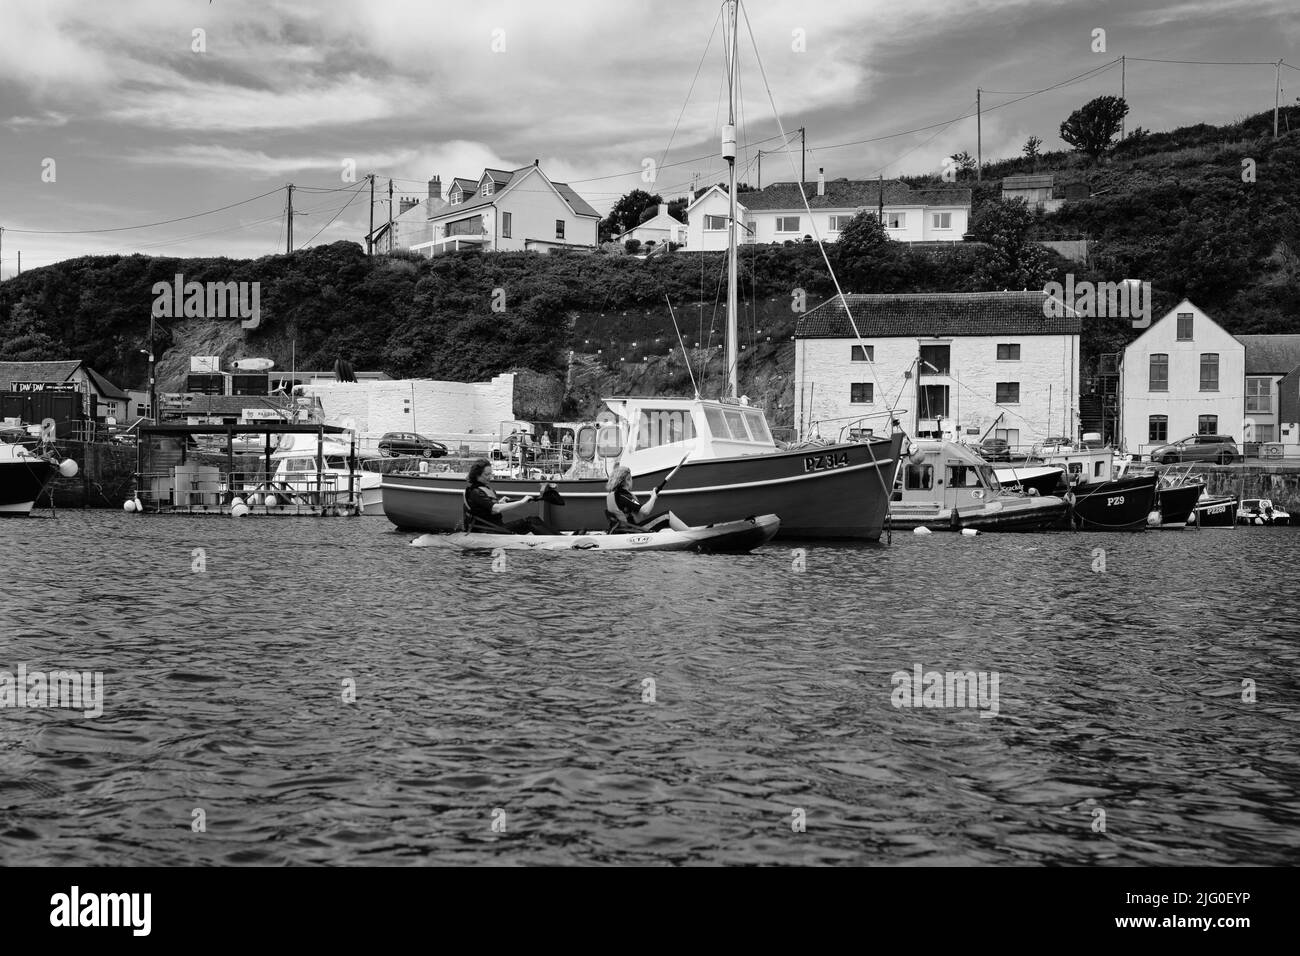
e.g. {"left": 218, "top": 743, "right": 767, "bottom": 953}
{"left": 794, "top": 336, "right": 1079, "bottom": 445}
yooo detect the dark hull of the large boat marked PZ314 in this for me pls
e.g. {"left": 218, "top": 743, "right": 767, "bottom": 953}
{"left": 384, "top": 433, "right": 902, "bottom": 541}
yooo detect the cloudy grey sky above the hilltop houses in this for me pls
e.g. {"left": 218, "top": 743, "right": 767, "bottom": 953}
{"left": 0, "top": 0, "right": 1300, "bottom": 278}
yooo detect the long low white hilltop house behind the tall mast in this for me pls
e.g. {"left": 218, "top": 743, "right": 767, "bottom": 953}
{"left": 686, "top": 174, "right": 971, "bottom": 251}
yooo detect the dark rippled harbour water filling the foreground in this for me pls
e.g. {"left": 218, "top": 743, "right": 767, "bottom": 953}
{"left": 0, "top": 511, "right": 1300, "bottom": 865}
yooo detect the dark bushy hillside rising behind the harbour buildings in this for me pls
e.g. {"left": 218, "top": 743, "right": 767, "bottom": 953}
{"left": 0, "top": 108, "right": 1300, "bottom": 424}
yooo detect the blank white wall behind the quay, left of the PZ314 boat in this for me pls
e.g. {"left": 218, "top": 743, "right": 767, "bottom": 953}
{"left": 303, "top": 372, "right": 515, "bottom": 454}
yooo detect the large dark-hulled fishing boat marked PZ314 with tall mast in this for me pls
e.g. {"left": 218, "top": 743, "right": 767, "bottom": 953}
{"left": 382, "top": 0, "right": 904, "bottom": 541}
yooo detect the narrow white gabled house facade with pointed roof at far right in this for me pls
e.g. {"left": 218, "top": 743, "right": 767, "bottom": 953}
{"left": 1118, "top": 299, "right": 1245, "bottom": 454}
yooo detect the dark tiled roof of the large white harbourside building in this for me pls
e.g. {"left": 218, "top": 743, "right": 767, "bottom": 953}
{"left": 794, "top": 291, "right": 1080, "bottom": 338}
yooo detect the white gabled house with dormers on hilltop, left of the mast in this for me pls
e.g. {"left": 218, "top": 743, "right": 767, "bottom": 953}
{"left": 411, "top": 160, "right": 601, "bottom": 256}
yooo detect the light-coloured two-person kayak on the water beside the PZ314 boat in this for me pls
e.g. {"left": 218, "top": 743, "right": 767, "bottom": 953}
{"left": 411, "top": 515, "right": 781, "bottom": 553}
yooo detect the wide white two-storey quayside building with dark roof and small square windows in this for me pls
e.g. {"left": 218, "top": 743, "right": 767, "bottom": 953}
{"left": 794, "top": 291, "right": 1080, "bottom": 447}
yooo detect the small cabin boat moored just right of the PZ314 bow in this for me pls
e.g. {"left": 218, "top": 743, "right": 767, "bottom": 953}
{"left": 889, "top": 440, "right": 1066, "bottom": 531}
